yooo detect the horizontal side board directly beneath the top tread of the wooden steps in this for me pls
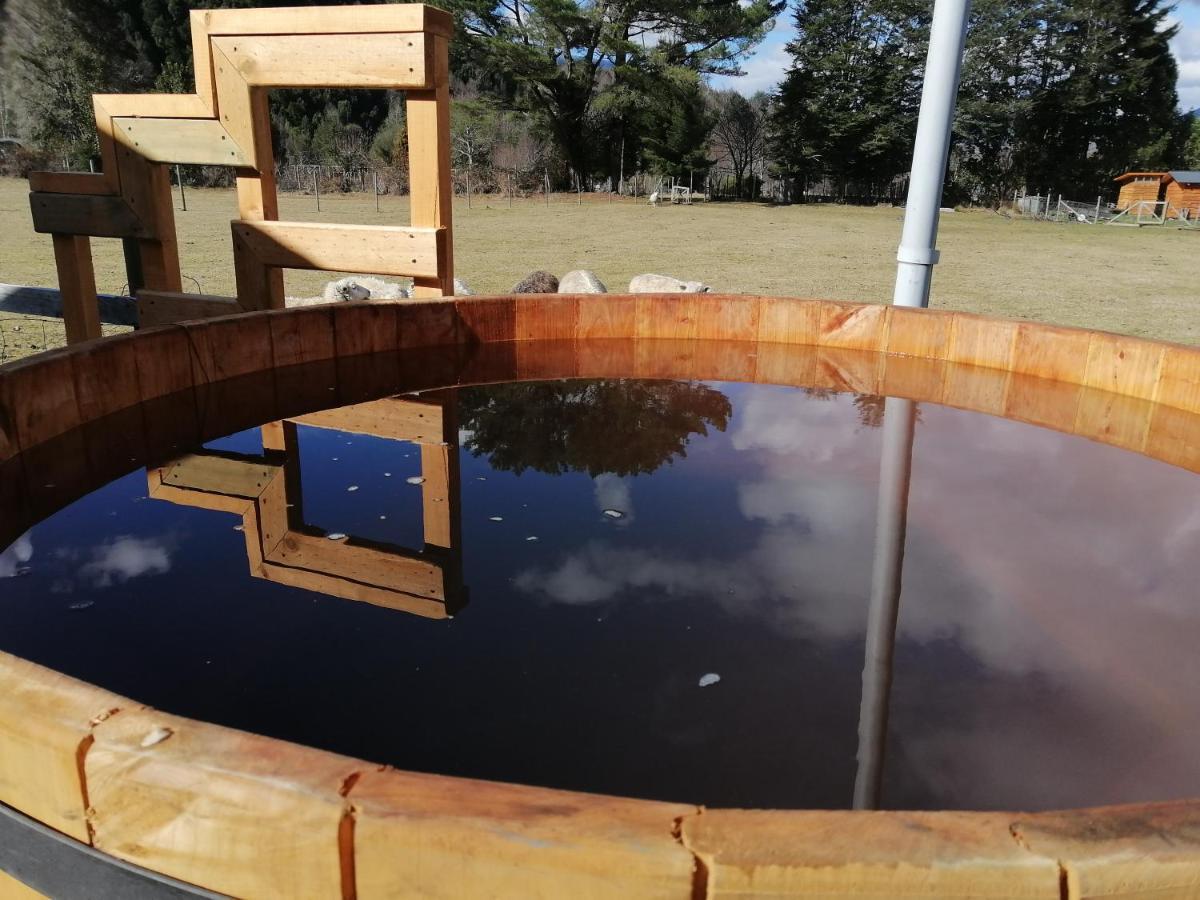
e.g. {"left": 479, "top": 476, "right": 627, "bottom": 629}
{"left": 212, "top": 32, "right": 432, "bottom": 90}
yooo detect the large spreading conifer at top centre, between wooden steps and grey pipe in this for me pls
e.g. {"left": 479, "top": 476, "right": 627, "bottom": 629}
{"left": 450, "top": 0, "right": 784, "bottom": 176}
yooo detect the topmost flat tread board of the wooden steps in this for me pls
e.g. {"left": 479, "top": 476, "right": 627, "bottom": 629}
{"left": 192, "top": 4, "right": 454, "bottom": 37}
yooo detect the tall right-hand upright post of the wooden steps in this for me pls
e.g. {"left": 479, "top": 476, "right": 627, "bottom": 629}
{"left": 404, "top": 36, "right": 454, "bottom": 298}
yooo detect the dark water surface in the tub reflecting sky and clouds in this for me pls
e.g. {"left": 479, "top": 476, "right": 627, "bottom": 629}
{"left": 0, "top": 379, "right": 1200, "bottom": 809}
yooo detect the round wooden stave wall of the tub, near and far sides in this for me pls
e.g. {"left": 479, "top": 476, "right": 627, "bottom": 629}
{"left": 0, "top": 294, "right": 1200, "bottom": 898}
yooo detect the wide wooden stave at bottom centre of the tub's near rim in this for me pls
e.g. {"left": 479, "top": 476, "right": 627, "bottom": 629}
{"left": 349, "top": 769, "right": 696, "bottom": 900}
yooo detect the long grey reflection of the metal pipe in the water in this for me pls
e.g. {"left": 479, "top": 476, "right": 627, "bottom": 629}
{"left": 854, "top": 397, "right": 917, "bottom": 809}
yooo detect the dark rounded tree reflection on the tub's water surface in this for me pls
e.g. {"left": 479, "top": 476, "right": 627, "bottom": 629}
{"left": 458, "top": 379, "right": 733, "bottom": 476}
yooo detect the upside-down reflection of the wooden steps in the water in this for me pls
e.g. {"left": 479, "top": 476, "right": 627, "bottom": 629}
{"left": 146, "top": 395, "right": 467, "bottom": 618}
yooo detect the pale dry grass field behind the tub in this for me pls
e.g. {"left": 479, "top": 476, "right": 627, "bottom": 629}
{"left": 0, "top": 179, "right": 1200, "bottom": 343}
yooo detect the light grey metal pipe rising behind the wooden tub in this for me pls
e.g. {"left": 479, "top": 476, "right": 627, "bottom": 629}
{"left": 892, "top": 0, "right": 971, "bottom": 306}
